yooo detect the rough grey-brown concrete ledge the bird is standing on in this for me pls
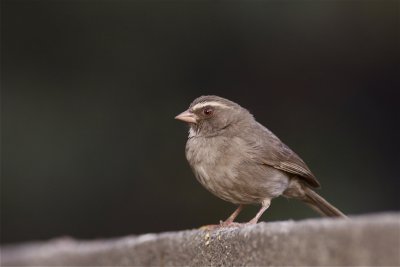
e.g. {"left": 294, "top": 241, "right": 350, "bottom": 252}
{"left": 1, "top": 213, "right": 400, "bottom": 266}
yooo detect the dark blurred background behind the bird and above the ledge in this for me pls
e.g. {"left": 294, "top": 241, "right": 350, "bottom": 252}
{"left": 1, "top": 0, "right": 400, "bottom": 246}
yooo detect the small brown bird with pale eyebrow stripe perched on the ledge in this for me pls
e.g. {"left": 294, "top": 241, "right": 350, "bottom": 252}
{"left": 175, "top": 95, "right": 346, "bottom": 226}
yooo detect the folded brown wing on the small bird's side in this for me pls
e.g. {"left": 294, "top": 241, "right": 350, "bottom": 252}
{"left": 252, "top": 124, "right": 320, "bottom": 187}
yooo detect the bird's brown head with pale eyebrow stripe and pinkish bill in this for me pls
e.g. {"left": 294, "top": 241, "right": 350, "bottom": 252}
{"left": 175, "top": 95, "right": 252, "bottom": 136}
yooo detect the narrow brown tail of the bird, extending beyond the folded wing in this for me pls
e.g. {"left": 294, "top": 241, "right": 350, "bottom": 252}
{"left": 303, "top": 186, "right": 347, "bottom": 218}
